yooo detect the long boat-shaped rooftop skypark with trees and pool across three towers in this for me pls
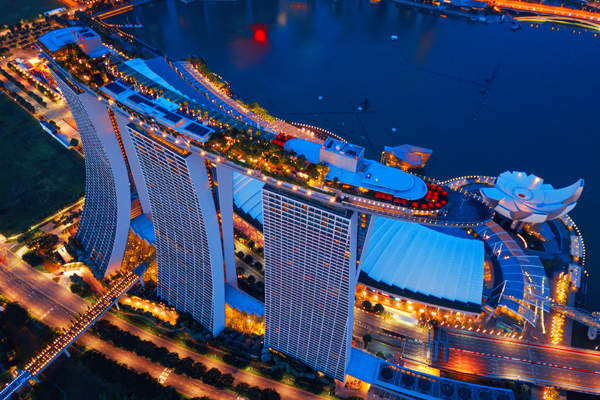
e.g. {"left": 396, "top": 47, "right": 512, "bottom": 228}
{"left": 38, "top": 26, "right": 494, "bottom": 227}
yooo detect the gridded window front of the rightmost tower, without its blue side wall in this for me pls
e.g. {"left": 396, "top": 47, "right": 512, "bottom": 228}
{"left": 263, "top": 191, "right": 350, "bottom": 379}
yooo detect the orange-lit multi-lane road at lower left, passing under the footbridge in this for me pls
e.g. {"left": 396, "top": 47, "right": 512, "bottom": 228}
{"left": 0, "top": 263, "right": 320, "bottom": 400}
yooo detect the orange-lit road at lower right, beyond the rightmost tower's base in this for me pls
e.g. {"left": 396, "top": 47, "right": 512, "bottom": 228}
{"left": 354, "top": 310, "right": 600, "bottom": 393}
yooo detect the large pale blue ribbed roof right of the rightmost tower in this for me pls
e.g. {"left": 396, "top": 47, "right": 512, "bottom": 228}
{"left": 362, "top": 217, "right": 485, "bottom": 306}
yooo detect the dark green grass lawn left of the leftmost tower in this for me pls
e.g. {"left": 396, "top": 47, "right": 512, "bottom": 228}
{"left": 0, "top": 93, "right": 85, "bottom": 237}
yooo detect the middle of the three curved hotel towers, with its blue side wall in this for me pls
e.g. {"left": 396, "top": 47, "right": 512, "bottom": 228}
{"left": 127, "top": 124, "right": 225, "bottom": 334}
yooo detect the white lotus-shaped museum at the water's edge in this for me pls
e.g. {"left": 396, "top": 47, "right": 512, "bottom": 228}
{"left": 480, "top": 171, "right": 583, "bottom": 223}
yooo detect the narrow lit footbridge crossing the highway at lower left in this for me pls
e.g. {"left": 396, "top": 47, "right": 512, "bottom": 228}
{"left": 0, "top": 263, "right": 147, "bottom": 400}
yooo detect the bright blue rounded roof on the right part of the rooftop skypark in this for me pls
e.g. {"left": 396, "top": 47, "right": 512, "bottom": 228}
{"left": 285, "top": 138, "right": 427, "bottom": 200}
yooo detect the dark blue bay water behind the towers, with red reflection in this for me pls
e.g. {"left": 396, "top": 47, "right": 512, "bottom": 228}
{"left": 108, "top": 0, "right": 600, "bottom": 311}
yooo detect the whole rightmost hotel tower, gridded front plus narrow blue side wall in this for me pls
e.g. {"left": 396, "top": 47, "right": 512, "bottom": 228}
{"left": 262, "top": 187, "right": 357, "bottom": 381}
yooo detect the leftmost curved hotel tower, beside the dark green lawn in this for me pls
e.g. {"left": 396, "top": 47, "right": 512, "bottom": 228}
{"left": 50, "top": 65, "right": 131, "bottom": 278}
